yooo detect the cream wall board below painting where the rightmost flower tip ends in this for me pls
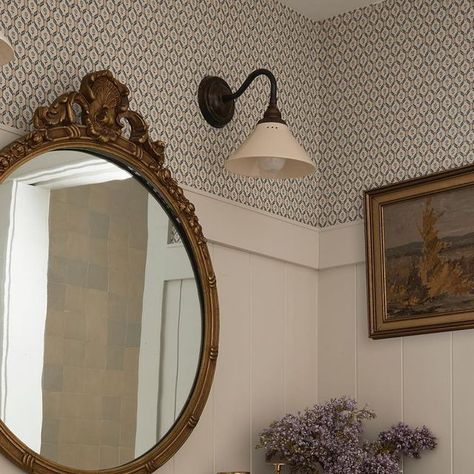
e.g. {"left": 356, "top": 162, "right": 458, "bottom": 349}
{"left": 403, "top": 333, "right": 452, "bottom": 474}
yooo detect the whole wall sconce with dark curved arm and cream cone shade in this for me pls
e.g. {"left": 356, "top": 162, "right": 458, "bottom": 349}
{"left": 198, "top": 69, "right": 316, "bottom": 179}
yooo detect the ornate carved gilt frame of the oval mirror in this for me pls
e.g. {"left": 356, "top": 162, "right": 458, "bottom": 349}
{"left": 0, "top": 71, "right": 219, "bottom": 474}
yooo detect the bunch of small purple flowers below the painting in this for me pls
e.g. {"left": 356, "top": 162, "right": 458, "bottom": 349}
{"left": 257, "top": 397, "right": 436, "bottom": 474}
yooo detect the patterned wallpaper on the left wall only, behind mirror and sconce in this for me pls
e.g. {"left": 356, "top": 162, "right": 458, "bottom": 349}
{"left": 0, "top": 0, "right": 318, "bottom": 225}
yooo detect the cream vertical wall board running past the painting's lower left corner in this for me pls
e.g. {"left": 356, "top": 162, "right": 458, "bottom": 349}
{"left": 355, "top": 264, "right": 402, "bottom": 437}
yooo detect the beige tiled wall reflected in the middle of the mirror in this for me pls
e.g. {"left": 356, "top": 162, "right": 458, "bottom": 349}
{"left": 41, "top": 179, "right": 147, "bottom": 469}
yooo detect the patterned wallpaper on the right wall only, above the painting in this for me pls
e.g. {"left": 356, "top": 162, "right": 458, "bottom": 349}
{"left": 317, "top": 0, "right": 474, "bottom": 226}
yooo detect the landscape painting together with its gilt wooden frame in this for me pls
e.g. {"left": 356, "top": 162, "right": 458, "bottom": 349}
{"left": 365, "top": 166, "right": 474, "bottom": 339}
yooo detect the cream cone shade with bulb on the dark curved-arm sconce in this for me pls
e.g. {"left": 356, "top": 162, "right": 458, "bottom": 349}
{"left": 225, "top": 122, "right": 316, "bottom": 179}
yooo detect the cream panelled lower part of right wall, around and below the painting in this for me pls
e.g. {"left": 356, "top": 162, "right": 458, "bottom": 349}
{"left": 318, "top": 222, "right": 474, "bottom": 474}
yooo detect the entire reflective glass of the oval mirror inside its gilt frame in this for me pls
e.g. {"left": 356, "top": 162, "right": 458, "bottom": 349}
{"left": 0, "top": 150, "right": 202, "bottom": 470}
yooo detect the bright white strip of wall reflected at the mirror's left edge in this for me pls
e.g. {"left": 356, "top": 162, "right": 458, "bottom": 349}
{"left": 1, "top": 183, "right": 49, "bottom": 452}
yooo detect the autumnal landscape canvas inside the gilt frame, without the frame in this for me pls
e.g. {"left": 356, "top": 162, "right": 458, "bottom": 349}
{"left": 383, "top": 186, "right": 474, "bottom": 319}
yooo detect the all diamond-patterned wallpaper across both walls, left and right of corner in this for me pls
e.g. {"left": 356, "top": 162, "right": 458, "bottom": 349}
{"left": 0, "top": 0, "right": 474, "bottom": 226}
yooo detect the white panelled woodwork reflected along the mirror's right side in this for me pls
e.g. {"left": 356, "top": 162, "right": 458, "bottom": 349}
{"left": 135, "top": 196, "right": 202, "bottom": 456}
